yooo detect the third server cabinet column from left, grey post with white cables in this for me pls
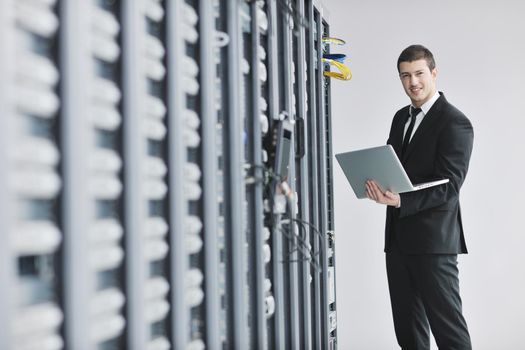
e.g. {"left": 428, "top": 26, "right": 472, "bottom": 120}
{"left": 121, "top": 0, "right": 173, "bottom": 349}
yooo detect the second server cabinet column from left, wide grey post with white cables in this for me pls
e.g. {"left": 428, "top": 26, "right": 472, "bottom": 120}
{"left": 59, "top": 1, "right": 127, "bottom": 349}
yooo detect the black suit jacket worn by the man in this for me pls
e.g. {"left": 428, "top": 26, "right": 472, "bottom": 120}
{"left": 385, "top": 92, "right": 474, "bottom": 254}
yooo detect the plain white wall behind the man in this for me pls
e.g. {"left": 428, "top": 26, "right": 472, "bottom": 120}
{"left": 323, "top": 0, "right": 525, "bottom": 350}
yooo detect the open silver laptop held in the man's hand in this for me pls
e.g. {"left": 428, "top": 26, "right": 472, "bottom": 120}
{"left": 335, "top": 145, "right": 448, "bottom": 198}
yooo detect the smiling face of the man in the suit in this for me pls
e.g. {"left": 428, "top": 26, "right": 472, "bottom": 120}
{"left": 399, "top": 59, "right": 437, "bottom": 108}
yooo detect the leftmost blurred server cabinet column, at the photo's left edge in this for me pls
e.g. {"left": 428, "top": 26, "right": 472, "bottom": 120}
{"left": 0, "top": 1, "right": 64, "bottom": 349}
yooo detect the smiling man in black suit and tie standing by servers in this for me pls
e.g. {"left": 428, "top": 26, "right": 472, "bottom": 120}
{"left": 365, "top": 45, "right": 474, "bottom": 350}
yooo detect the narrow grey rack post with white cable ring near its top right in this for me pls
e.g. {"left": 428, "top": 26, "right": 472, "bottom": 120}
{"left": 199, "top": 1, "right": 221, "bottom": 349}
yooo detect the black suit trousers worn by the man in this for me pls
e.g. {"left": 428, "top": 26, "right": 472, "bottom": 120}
{"left": 386, "top": 242, "right": 472, "bottom": 350}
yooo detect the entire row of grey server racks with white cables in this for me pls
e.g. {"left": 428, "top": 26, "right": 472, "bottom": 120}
{"left": 0, "top": 0, "right": 337, "bottom": 349}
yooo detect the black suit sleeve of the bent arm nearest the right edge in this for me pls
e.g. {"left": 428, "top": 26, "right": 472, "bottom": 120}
{"left": 399, "top": 114, "right": 474, "bottom": 217}
